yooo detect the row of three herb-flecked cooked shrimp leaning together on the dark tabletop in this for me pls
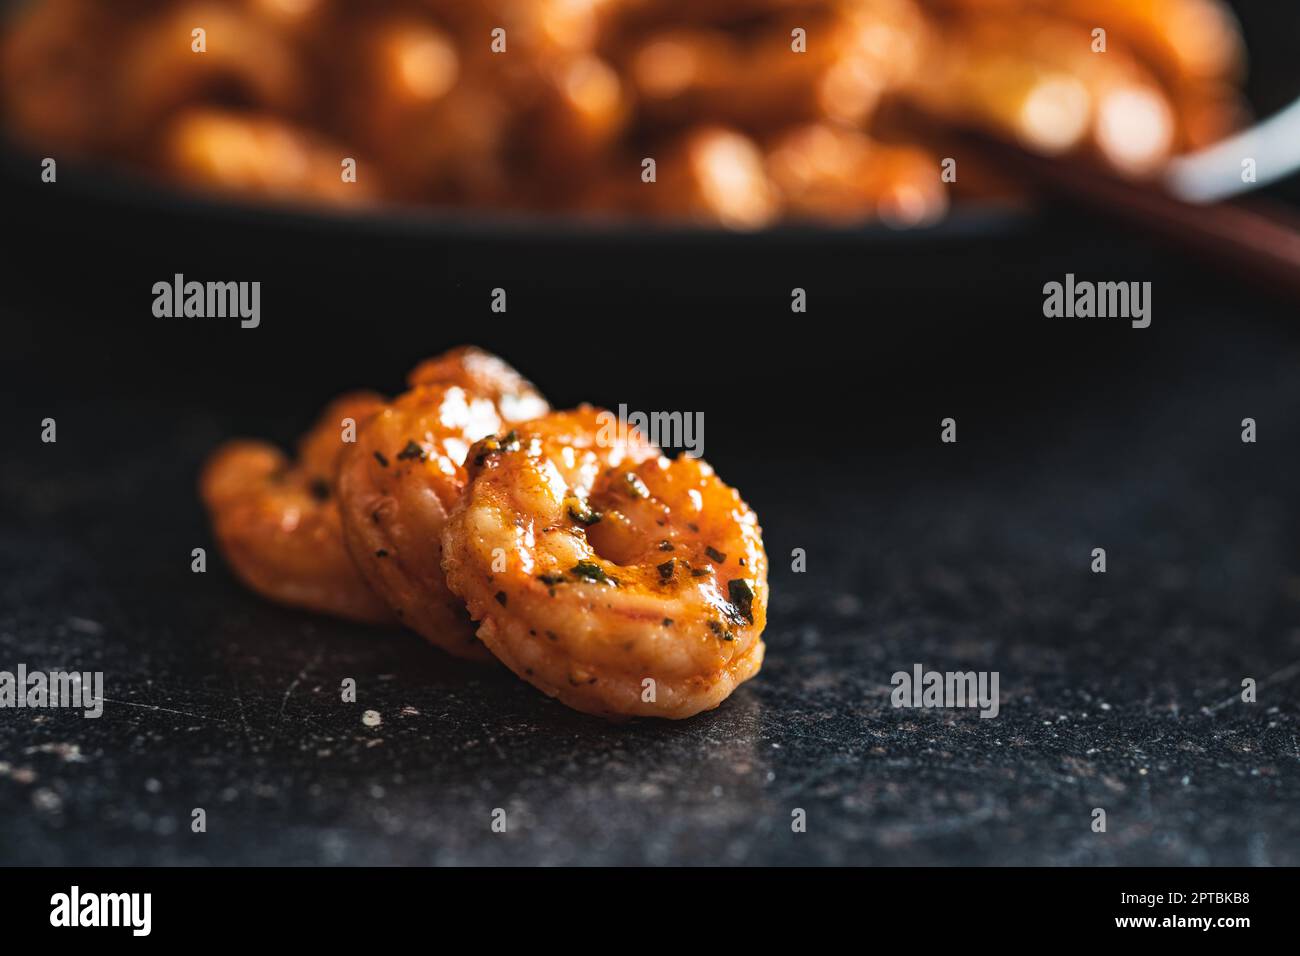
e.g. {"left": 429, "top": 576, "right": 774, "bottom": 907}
{"left": 200, "top": 347, "right": 768, "bottom": 719}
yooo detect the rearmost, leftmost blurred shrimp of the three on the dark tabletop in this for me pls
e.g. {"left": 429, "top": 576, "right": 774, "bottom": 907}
{"left": 199, "top": 392, "right": 393, "bottom": 623}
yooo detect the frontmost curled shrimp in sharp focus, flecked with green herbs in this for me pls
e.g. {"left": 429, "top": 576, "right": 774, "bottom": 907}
{"left": 443, "top": 406, "right": 767, "bottom": 718}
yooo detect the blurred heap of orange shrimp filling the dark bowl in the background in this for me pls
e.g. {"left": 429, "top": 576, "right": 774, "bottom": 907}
{"left": 0, "top": 0, "right": 1245, "bottom": 229}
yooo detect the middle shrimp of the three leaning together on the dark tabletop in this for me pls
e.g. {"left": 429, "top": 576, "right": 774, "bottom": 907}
{"left": 338, "top": 349, "right": 547, "bottom": 661}
